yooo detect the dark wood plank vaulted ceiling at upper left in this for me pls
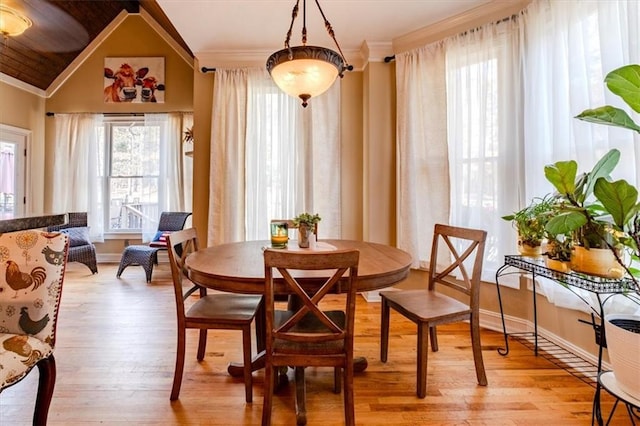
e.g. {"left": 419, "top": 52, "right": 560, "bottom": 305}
{"left": 0, "top": 0, "right": 191, "bottom": 90}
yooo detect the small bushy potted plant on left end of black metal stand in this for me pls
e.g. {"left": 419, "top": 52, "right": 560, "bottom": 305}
{"left": 502, "top": 196, "right": 554, "bottom": 256}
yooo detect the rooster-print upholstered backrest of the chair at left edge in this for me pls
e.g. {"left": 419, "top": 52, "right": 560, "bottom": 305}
{"left": 0, "top": 230, "right": 69, "bottom": 348}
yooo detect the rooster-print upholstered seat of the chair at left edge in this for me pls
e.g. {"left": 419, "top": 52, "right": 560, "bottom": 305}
{"left": 0, "top": 333, "right": 53, "bottom": 389}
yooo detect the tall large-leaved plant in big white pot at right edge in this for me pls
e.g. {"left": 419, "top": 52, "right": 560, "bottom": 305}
{"left": 577, "top": 64, "right": 640, "bottom": 399}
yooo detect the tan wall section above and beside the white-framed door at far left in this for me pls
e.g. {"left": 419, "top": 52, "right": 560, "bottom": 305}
{"left": 0, "top": 82, "right": 51, "bottom": 215}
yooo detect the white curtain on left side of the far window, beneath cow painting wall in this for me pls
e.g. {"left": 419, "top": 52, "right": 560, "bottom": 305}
{"left": 51, "top": 114, "right": 104, "bottom": 241}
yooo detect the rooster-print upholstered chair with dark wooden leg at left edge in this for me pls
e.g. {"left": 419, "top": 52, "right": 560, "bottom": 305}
{"left": 0, "top": 230, "right": 69, "bottom": 425}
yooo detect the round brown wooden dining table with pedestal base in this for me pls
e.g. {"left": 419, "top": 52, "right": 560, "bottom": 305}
{"left": 185, "top": 239, "right": 413, "bottom": 424}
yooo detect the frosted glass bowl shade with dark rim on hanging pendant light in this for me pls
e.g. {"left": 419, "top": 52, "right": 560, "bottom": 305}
{"left": 267, "top": 46, "right": 345, "bottom": 106}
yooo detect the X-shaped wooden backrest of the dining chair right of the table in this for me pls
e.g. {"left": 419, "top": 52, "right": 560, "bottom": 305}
{"left": 429, "top": 224, "right": 487, "bottom": 307}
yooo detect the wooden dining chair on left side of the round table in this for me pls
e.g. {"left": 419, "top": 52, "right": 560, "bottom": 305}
{"left": 167, "top": 228, "right": 262, "bottom": 402}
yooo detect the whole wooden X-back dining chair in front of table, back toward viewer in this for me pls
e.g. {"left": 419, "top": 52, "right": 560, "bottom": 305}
{"left": 262, "top": 249, "right": 360, "bottom": 426}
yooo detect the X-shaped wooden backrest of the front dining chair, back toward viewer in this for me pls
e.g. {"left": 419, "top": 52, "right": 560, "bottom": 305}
{"left": 264, "top": 249, "right": 360, "bottom": 352}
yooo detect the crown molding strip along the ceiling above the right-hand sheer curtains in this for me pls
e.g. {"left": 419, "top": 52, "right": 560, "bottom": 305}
{"left": 393, "top": 0, "right": 532, "bottom": 53}
